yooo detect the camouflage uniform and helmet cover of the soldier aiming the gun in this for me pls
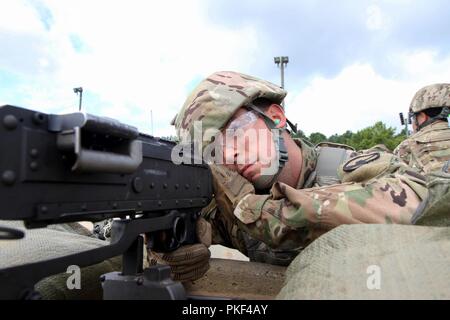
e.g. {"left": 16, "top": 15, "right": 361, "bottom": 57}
{"left": 174, "top": 72, "right": 426, "bottom": 261}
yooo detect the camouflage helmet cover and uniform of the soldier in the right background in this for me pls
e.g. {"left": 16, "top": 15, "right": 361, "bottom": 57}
{"left": 394, "top": 84, "right": 450, "bottom": 174}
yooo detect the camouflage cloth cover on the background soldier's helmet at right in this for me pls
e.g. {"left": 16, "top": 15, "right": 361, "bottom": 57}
{"left": 409, "top": 83, "right": 450, "bottom": 113}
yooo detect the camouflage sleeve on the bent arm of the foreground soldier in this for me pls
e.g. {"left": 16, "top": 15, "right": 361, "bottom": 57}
{"left": 230, "top": 175, "right": 421, "bottom": 249}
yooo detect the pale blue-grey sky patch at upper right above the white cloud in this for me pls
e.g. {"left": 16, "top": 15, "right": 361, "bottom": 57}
{"left": 209, "top": 0, "right": 450, "bottom": 76}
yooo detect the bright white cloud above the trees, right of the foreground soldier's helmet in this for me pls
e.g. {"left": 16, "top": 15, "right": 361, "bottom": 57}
{"left": 286, "top": 51, "right": 450, "bottom": 136}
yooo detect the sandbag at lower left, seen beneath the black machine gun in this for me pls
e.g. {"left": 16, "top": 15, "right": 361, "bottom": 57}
{"left": 0, "top": 221, "right": 121, "bottom": 300}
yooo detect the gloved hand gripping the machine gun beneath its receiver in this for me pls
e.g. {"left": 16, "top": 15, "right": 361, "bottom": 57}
{"left": 147, "top": 218, "right": 211, "bottom": 281}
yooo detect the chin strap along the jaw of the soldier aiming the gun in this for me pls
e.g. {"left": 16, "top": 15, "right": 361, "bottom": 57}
{"left": 249, "top": 105, "right": 289, "bottom": 190}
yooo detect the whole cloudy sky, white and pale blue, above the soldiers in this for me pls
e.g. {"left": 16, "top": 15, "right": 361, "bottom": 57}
{"left": 0, "top": 0, "right": 450, "bottom": 136}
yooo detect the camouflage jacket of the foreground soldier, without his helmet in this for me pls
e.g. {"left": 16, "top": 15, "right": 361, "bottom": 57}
{"left": 204, "top": 146, "right": 427, "bottom": 256}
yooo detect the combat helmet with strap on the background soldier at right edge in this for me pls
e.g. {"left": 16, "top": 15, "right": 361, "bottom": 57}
{"left": 409, "top": 83, "right": 450, "bottom": 130}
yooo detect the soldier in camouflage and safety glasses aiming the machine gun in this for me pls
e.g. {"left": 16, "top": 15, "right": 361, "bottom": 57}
{"left": 156, "top": 72, "right": 427, "bottom": 276}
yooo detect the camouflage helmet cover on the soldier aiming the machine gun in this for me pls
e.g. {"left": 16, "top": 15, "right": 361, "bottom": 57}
{"left": 173, "top": 71, "right": 286, "bottom": 146}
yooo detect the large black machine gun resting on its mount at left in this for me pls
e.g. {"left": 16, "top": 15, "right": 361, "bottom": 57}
{"left": 0, "top": 105, "right": 212, "bottom": 299}
